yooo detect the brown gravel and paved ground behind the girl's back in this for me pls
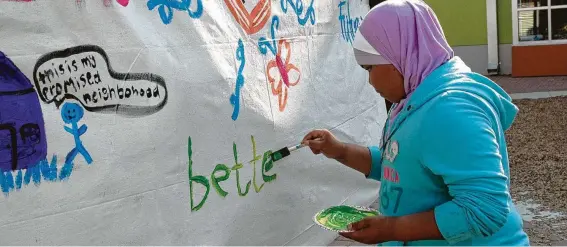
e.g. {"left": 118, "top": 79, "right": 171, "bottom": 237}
{"left": 330, "top": 76, "right": 567, "bottom": 246}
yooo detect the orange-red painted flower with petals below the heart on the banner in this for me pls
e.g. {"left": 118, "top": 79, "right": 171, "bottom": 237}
{"left": 266, "top": 39, "right": 301, "bottom": 111}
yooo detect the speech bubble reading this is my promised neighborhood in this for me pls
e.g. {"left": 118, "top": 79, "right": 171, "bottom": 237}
{"left": 33, "top": 45, "right": 167, "bottom": 116}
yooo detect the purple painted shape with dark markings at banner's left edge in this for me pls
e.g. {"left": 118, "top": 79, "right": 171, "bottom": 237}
{"left": 0, "top": 51, "right": 47, "bottom": 171}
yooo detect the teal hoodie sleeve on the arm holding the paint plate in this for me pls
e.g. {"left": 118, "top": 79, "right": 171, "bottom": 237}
{"left": 420, "top": 96, "right": 510, "bottom": 245}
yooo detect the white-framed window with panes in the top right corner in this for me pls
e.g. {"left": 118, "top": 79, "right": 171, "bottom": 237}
{"left": 512, "top": 0, "right": 567, "bottom": 44}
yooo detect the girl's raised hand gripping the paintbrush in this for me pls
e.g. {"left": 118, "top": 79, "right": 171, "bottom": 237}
{"left": 301, "top": 129, "right": 346, "bottom": 159}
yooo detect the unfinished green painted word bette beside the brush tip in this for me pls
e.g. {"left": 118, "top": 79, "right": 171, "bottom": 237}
{"left": 187, "top": 136, "right": 276, "bottom": 211}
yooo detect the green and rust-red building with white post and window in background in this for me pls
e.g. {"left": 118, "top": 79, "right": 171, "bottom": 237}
{"left": 369, "top": 0, "right": 567, "bottom": 76}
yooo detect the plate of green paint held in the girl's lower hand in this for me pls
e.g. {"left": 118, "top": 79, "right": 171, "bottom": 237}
{"left": 313, "top": 205, "right": 379, "bottom": 232}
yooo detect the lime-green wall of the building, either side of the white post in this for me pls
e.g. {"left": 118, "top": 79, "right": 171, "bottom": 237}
{"left": 425, "top": 0, "right": 512, "bottom": 46}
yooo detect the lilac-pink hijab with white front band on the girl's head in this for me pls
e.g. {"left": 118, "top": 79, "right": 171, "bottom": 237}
{"left": 353, "top": 0, "right": 454, "bottom": 122}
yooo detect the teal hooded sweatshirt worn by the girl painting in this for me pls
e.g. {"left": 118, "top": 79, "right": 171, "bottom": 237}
{"left": 368, "top": 57, "right": 529, "bottom": 246}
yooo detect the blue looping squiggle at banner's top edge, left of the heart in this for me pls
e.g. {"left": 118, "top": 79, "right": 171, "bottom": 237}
{"left": 147, "top": 0, "right": 203, "bottom": 25}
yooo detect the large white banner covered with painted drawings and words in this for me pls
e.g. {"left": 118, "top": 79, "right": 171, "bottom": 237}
{"left": 0, "top": 0, "right": 386, "bottom": 245}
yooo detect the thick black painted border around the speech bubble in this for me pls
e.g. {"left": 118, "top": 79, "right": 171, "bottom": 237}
{"left": 33, "top": 45, "right": 168, "bottom": 116}
